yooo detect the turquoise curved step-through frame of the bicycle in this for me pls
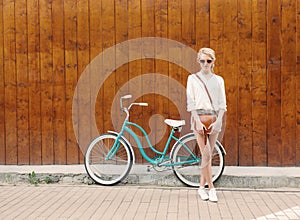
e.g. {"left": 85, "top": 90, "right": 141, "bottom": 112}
{"left": 106, "top": 118, "right": 200, "bottom": 167}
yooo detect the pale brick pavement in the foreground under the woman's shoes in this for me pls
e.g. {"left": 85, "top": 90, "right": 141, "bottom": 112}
{"left": 0, "top": 184, "right": 300, "bottom": 220}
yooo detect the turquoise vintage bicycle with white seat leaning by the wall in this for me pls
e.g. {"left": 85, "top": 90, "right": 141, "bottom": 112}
{"left": 84, "top": 95, "right": 226, "bottom": 187}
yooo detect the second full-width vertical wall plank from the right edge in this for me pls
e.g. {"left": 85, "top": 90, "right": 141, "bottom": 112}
{"left": 267, "top": 0, "right": 282, "bottom": 166}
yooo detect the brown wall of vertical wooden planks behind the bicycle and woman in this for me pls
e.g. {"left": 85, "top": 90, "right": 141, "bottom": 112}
{"left": 0, "top": 0, "right": 300, "bottom": 166}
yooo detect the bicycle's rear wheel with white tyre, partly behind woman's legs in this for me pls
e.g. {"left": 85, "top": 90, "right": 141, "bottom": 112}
{"left": 171, "top": 133, "right": 225, "bottom": 187}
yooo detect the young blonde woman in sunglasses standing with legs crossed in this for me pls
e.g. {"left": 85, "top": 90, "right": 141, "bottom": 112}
{"left": 186, "top": 48, "right": 226, "bottom": 202}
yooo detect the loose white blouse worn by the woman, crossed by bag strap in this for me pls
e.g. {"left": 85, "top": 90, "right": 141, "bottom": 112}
{"left": 186, "top": 71, "right": 227, "bottom": 111}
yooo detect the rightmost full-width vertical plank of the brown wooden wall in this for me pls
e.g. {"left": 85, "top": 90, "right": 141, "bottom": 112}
{"left": 281, "top": 0, "right": 299, "bottom": 166}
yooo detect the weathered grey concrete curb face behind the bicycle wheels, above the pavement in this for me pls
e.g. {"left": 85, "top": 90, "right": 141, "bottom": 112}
{"left": 0, "top": 172, "right": 300, "bottom": 189}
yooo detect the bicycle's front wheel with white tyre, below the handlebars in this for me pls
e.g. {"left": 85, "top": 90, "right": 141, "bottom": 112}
{"left": 84, "top": 134, "right": 133, "bottom": 186}
